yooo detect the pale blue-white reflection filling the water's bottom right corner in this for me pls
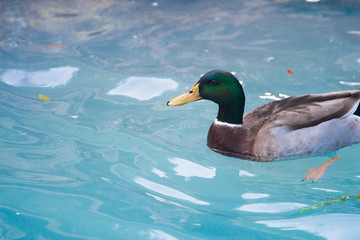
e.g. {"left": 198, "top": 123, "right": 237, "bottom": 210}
{"left": 256, "top": 213, "right": 360, "bottom": 240}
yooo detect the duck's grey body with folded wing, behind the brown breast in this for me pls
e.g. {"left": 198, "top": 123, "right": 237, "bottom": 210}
{"left": 244, "top": 91, "right": 360, "bottom": 159}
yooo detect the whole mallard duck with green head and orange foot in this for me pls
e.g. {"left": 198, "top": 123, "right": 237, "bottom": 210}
{"left": 167, "top": 70, "right": 360, "bottom": 181}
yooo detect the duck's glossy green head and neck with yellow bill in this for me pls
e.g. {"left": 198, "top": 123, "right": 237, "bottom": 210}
{"left": 167, "top": 70, "right": 245, "bottom": 124}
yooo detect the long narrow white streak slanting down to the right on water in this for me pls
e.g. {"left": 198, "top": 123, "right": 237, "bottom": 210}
{"left": 134, "top": 177, "right": 210, "bottom": 205}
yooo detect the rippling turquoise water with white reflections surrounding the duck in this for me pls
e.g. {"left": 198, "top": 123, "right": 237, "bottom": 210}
{"left": 0, "top": 0, "right": 360, "bottom": 240}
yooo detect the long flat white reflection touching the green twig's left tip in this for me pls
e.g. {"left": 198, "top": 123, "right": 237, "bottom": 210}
{"left": 235, "top": 202, "right": 308, "bottom": 213}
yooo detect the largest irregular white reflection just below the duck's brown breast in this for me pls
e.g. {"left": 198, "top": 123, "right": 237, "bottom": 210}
{"left": 169, "top": 158, "right": 216, "bottom": 178}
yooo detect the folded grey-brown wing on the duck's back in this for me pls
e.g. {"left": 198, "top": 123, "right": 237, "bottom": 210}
{"left": 244, "top": 90, "right": 360, "bottom": 129}
